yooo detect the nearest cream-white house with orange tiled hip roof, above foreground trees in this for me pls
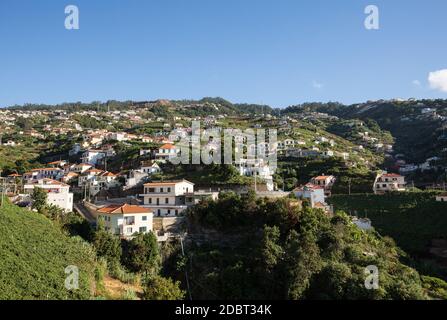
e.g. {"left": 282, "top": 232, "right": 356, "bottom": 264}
{"left": 97, "top": 204, "right": 153, "bottom": 238}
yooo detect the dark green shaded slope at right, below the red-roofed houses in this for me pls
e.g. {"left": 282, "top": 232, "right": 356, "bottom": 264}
{"left": 328, "top": 192, "right": 447, "bottom": 254}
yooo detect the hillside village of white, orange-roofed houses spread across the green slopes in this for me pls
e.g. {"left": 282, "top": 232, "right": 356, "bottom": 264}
{"left": 0, "top": 98, "right": 447, "bottom": 300}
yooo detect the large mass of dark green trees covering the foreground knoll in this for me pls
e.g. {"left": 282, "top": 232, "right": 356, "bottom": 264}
{"left": 162, "top": 193, "right": 443, "bottom": 299}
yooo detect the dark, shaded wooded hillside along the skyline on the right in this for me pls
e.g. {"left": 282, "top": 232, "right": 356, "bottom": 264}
{"left": 283, "top": 99, "right": 447, "bottom": 163}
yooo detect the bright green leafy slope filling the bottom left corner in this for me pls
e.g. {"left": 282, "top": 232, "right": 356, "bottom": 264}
{"left": 0, "top": 204, "right": 96, "bottom": 300}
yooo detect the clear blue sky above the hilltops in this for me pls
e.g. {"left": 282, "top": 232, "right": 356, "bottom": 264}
{"left": 0, "top": 0, "right": 447, "bottom": 107}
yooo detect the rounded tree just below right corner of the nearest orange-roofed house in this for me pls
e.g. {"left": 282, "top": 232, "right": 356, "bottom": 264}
{"left": 126, "top": 232, "right": 161, "bottom": 276}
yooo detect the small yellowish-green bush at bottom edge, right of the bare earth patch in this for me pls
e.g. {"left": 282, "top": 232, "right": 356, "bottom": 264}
{"left": 143, "top": 275, "right": 185, "bottom": 300}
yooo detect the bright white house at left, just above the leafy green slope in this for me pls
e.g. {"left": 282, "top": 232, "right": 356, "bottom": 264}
{"left": 23, "top": 179, "right": 73, "bottom": 212}
